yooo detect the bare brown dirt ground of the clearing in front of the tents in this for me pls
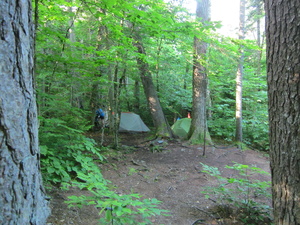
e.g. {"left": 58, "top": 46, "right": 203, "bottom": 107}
{"left": 47, "top": 133, "right": 271, "bottom": 225}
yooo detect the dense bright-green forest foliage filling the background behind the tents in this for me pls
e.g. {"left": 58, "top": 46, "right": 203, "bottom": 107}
{"left": 34, "top": 0, "right": 269, "bottom": 224}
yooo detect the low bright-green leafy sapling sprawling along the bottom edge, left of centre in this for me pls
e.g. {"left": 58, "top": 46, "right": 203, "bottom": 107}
{"left": 67, "top": 168, "right": 167, "bottom": 224}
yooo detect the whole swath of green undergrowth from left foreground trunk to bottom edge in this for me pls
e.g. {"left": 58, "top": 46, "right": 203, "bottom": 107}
{"left": 40, "top": 115, "right": 167, "bottom": 225}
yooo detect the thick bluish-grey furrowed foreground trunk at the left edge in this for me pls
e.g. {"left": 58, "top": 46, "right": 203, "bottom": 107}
{"left": 0, "top": 0, "right": 50, "bottom": 225}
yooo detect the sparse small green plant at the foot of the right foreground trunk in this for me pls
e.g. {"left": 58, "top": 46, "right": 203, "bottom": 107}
{"left": 201, "top": 163, "right": 271, "bottom": 225}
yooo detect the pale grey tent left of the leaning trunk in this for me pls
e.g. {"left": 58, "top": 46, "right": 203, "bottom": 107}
{"left": 119, "top": 112, "right": 150, "bottom": 132}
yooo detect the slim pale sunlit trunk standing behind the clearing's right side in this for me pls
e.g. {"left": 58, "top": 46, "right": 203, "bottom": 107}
{"left": 235, "top": 0, "right": 246, "bottom": 145}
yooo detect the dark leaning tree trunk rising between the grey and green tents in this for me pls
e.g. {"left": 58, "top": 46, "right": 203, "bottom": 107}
{"left": 134, "top": 34, "right": 174, "bottom": 137}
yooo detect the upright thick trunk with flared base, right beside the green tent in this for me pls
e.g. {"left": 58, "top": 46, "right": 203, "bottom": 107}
{"left": 189, "top": 0, "right": 212, "bottom": 144}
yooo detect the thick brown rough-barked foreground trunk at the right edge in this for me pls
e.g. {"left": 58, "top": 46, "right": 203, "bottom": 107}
{"left": 265, "top": 0, "right": 300, "bottom": 225}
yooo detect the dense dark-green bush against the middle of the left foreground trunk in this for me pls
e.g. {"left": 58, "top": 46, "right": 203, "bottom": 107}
{"left": 40, "top": 115, "right": 103, "bottom": 184}
